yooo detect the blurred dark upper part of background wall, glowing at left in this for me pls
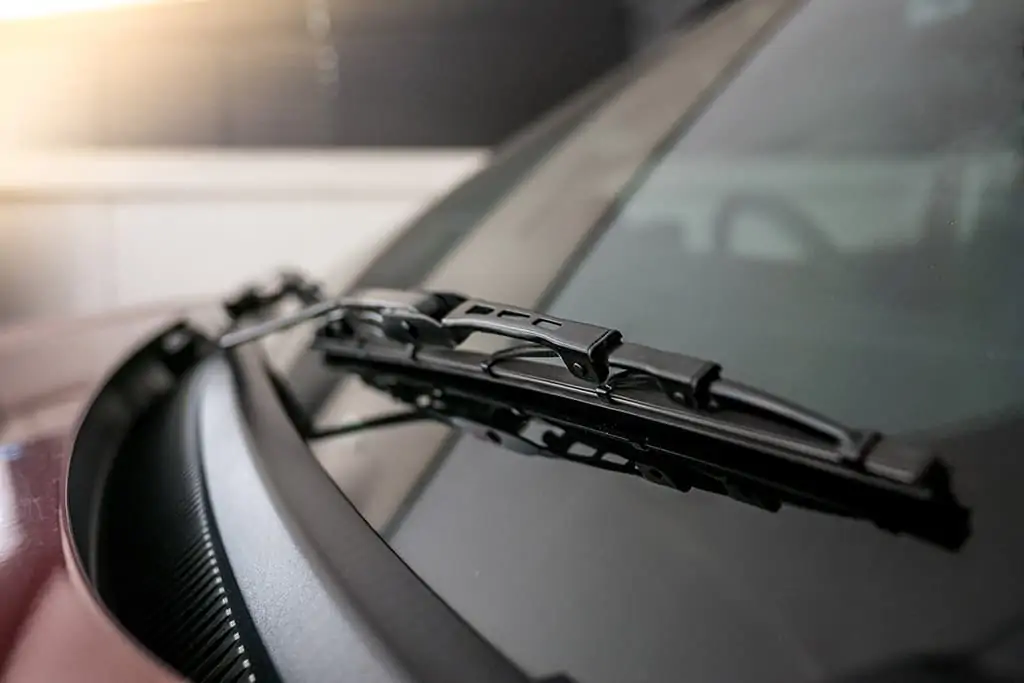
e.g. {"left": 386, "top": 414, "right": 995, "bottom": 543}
{"left": 0, "top": 0, "right": 632, "bottom": 147}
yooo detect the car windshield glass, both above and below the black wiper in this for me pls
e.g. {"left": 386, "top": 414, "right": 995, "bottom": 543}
{"left": 373, "top": 0, "right": 1024, "bottom": 683}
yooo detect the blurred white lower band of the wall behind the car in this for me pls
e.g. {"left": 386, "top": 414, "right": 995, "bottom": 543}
{"left": 0, "top": 151, "right": 485, "bottom": 325}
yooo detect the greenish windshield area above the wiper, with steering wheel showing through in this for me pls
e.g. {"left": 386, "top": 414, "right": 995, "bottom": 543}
{"left": 552, "top": 0, "right": 1024, "bottom": 430}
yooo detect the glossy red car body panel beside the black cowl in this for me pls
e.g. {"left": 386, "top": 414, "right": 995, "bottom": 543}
{"left": 0, "top": 306, "right": 193, "bottom": 683}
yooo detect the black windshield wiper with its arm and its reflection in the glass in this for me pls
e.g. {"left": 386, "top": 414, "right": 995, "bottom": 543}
{"left": 221, "top": 290, "right": 969, "bottom": 549}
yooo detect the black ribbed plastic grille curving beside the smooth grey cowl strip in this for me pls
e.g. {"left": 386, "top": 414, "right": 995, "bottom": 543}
{"left": 97, "top": 399, "right": 276, "bottom": 683}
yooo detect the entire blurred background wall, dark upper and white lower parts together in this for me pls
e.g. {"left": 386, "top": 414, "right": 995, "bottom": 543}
{"left": 0, "top": 0, "right": 697, "bottom": 325}
